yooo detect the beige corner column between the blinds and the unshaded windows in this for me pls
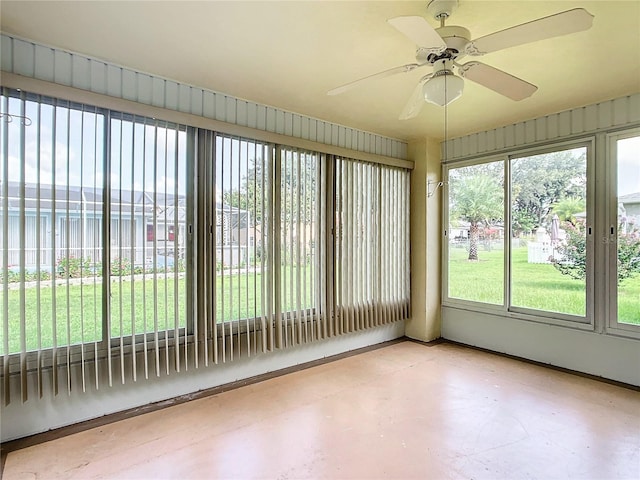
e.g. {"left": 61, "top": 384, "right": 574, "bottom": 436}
{"left": 405, "top": 138, "right": 442, "bottom": 342}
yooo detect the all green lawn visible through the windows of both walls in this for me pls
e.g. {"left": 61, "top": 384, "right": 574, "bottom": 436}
{"left": 0, "top": 248, "right": 640, "bottom": 354}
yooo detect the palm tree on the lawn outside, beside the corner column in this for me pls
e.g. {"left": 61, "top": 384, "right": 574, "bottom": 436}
{"left": 450, "top": 174, "right": 503, "bottom": 261}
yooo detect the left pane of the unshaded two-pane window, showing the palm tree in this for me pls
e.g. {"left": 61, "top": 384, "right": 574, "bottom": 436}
{"left": 447, "top": 161, "right": 505, "bottom": 305}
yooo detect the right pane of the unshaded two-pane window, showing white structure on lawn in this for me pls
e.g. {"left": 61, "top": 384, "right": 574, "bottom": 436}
{"left": 509, "top": 147, "right": 589, "bottom": 318}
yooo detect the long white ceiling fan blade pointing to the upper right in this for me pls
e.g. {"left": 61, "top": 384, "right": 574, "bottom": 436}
{"left": 465, "top": 8, "right": 593, "bottom": 56}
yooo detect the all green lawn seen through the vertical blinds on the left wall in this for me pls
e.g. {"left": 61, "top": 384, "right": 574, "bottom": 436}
{"left": 0, "top": 267, "right": 314, "bottom": 354}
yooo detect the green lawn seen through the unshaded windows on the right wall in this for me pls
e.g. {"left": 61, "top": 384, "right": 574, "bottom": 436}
{"left": 449, "top": 247, "right": 640, "bottom": 324}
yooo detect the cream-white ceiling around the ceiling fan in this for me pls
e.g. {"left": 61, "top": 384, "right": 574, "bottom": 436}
{"left": 0, "top": 0, "right": 640, "bottom": 140}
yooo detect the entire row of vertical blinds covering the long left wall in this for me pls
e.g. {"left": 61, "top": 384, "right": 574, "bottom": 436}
{"left": 0, "top": 89, "right": 409, "bottom": 403}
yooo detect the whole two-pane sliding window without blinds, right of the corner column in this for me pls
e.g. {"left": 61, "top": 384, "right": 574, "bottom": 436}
{"left": 445, "top": 144, "right": 592, "bottom": 323}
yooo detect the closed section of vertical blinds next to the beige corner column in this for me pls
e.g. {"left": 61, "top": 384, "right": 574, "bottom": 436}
{"left": 334, "top": 158, "right": 410, "bottom": 334}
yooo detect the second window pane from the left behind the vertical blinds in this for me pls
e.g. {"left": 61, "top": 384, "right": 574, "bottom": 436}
{"left": 107, "top": 112, "right": 192, "bottom": 374}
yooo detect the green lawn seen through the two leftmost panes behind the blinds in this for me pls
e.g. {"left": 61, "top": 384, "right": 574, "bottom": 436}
{"left": 0, "top": 277, "right": 186, "bottom": 353}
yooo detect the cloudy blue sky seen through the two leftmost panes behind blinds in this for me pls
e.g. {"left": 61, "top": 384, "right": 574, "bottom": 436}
{"left": 8, "top": 99, "right": 187, "bottom": 195}
